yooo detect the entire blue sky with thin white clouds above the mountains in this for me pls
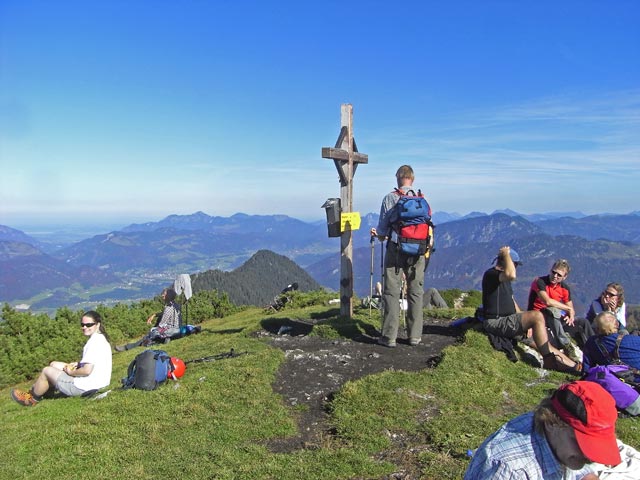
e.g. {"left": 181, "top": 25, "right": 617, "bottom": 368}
{"left": 0, "top": 0, "right": 640, "bottom": 230}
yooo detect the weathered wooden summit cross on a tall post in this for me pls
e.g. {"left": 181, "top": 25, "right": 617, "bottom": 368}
{"left": 322, "top": 103, "right": 369, "bottom": 319}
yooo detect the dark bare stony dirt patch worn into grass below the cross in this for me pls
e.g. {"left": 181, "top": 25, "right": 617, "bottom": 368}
{"left": 255, "top": 318, "right": 461, "bottom": 458}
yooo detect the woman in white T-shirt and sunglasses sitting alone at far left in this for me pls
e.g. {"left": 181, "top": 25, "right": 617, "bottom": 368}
{"left": 11, "top": 311, "right": 112, "bottom": 407}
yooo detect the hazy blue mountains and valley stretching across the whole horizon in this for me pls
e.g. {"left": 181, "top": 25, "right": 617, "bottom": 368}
{"left": 0, "top": 210, "right": 640, "bottom": 307}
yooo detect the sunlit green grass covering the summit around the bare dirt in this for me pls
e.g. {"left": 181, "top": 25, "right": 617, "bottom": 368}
{"left": 0, "top": 306, "right": 640, "bottom": 480}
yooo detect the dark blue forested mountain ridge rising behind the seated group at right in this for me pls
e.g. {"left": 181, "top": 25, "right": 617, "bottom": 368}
{"left": 306, "top": 213, "right": 640, "bottom": 314}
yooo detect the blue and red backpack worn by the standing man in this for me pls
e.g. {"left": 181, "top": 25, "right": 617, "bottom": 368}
{"left": 391, "top": 188, "right": 433, "bottom": 256}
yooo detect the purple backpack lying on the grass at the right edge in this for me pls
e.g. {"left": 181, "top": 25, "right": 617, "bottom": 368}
{"left": 584, "top": 365, "right": 640, "bottom": 416}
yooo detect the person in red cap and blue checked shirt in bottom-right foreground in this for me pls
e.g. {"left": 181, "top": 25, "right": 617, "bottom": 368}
{"left": 464, "top": 381, "right": 621, "bottom": 480}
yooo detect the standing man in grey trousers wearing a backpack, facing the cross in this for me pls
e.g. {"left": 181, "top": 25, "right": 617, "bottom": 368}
{"left": 371, "top": 165, "right": 431, "bottom": 347}
